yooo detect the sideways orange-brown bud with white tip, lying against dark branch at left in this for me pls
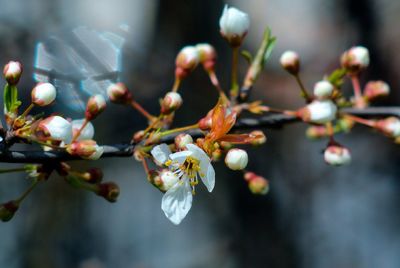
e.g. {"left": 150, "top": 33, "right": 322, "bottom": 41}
{"left": 67, "top": 140, "right": 104, "bottom": 160}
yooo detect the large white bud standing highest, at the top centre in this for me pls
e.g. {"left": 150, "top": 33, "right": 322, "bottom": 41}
{"left": 219, "top": 5, "right": 250, "bottom": 47}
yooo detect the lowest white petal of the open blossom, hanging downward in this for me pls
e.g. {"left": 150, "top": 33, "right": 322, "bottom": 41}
{"left": 161, "top": 182, "right": 193, "bottom": 225}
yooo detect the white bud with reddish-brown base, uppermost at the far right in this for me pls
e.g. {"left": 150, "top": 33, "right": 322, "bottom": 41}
{"left": 340, "top": 46, "right": 369, "bottom": 74}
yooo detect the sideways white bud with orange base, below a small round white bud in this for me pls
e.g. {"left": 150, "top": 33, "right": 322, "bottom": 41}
{"left": 297, "top": 100, "right": 337, "bottom": 124}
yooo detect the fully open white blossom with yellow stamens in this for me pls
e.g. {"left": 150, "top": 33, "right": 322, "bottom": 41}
{"left": 151, "top": 144, "right": 215, "bottom": 224}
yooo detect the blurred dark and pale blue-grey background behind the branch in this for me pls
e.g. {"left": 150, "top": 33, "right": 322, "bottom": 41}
{"left": 0, "top": 0, "right": 400, "bottom": 268}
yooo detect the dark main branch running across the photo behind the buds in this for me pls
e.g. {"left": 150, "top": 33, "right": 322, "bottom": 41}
{"left": 0, "top": 107, "right": 400, "bottom": 163}
